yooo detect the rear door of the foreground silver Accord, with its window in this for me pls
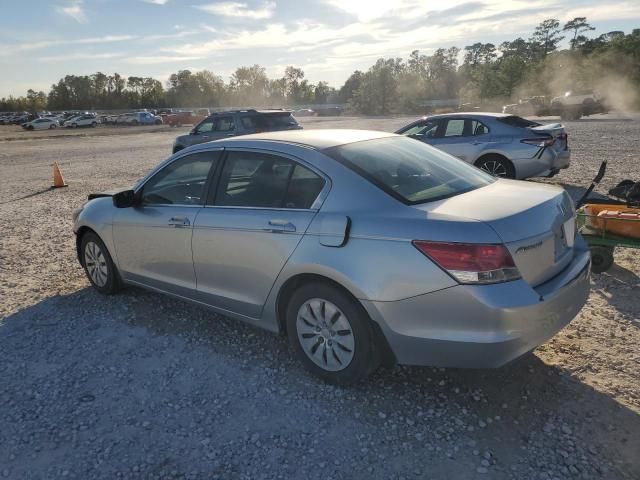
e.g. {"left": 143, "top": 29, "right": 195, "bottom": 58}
{"left": 192, "top": 149, "right": 328, "bottom": 318}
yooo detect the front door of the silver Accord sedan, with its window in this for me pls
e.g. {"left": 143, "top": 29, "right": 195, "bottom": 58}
{"left": 113, "top": 150, "right": 221, "bottom": 295}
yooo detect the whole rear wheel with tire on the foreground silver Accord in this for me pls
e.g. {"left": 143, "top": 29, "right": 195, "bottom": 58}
{"left": 286, "top": 283, "right": 381, "bottom": 385}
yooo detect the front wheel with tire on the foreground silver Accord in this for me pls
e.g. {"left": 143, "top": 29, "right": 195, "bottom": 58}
{"left": 80, "top": 232, "right": 120, "bottom": 295}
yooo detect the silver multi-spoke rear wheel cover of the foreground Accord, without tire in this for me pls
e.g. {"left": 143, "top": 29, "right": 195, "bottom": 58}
{"left": 296, "top": 298, "right": 355, "bottom": 372}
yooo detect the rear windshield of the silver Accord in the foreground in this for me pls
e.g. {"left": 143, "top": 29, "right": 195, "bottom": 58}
{"left": 324, "top": 137, "right": 495, "bottom": 205}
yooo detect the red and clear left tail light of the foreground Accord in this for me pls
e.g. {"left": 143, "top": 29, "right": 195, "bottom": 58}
{"left": 413, "top": 240, "right": 520, "bottom": 284}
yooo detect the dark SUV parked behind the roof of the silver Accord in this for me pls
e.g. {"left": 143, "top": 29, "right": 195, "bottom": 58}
{"left": 173, "top": 110, "right": 302, "bottom": 153}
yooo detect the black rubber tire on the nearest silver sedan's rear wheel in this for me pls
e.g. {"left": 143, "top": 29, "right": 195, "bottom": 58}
{"left": 286, "top": 283, "right": 381, "bottom": 385}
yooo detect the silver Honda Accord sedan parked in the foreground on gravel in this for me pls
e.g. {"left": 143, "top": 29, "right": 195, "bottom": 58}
{"left": 74, "top": 130, "right": 590, "bottom": 384}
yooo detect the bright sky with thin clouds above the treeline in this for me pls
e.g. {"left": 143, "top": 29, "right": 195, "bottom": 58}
{"left": 0, "top": 0, "right": 640, "bottom": 97}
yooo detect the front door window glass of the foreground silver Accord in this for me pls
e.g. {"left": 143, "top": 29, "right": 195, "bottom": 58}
{"left": 142, "top": 152, "right": 218, "bottom": 205}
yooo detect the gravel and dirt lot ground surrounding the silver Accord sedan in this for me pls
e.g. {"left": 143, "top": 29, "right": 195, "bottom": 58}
{"left": 0, "top": 115, "right": 640, "bottom": 480}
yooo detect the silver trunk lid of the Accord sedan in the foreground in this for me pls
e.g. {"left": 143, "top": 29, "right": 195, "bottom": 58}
{"left": 416, "top": 180, "right": 575, "bottom": 286}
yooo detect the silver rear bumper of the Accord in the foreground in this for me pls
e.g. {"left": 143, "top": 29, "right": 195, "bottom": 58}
{"left": 363, "top": 239, "right": 591, "bottom": 368}
